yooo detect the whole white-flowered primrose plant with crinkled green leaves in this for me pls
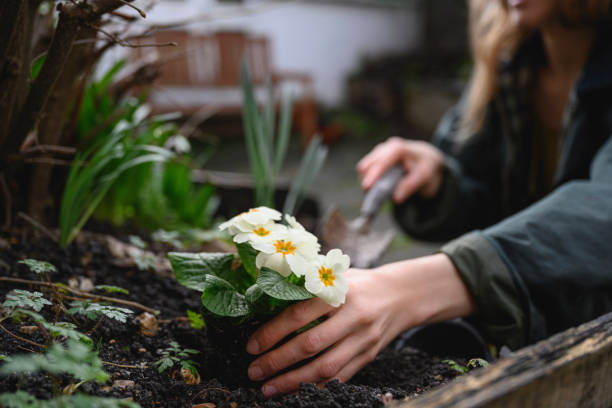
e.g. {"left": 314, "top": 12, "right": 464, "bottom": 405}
{"left": 168, "top": 207, "right": 350, "bottom": 318}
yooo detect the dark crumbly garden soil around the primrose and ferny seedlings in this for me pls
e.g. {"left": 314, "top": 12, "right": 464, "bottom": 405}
{"left": 0, "top": 234, "right": 461, "bottom": 407}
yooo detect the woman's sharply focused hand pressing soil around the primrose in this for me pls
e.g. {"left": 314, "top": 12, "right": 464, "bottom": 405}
{"left": 247, "top": 254, "right": 474, "bottom": 396}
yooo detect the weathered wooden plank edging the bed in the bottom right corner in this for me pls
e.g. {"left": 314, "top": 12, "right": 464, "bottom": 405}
{"left": 400, "top": 313, "right": 612, "bottom": 408}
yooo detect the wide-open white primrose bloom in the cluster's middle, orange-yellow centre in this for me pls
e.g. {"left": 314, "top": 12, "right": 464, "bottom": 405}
{"left": 251, "top": 228, "right": 320, "bottom": 277}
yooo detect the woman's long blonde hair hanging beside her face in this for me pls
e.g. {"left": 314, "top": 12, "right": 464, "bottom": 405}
{"left": 461, "top": 0, "right": 612, "bottom": 136}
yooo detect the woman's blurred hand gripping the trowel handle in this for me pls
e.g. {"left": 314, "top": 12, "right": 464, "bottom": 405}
{"left": 357, "top": 137, "right": 444, "bottom": 203}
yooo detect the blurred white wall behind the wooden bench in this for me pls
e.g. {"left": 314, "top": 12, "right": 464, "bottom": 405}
{"left": 133, "top": 0, "right": 421, "bottom": 104}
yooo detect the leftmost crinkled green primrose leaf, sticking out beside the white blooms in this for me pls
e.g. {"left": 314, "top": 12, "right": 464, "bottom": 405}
{"left": 168, "top": 252, "right": 234, "bottom": 292}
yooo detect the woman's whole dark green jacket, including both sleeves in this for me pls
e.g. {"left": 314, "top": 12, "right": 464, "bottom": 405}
{"left": 395, "top": 29, "right": 612, "bottom": 349}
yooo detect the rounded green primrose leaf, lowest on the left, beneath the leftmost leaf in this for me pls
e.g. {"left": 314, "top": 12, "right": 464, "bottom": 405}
{"left": 202, "top": 275, "right": 251, "bottom": 317}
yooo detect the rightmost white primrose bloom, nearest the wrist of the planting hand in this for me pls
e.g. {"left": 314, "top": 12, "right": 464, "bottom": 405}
{"left": 304, "top": 249, "right": 351, "bottom": 307}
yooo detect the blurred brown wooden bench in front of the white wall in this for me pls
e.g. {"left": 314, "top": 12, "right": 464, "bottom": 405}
{"left": 133, "top": 30, "right": 317, "bottom": 142}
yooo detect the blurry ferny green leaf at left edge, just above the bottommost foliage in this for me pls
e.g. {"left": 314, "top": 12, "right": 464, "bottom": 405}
{"left": 0, "top": 340, "right": 110, "bottom": 383}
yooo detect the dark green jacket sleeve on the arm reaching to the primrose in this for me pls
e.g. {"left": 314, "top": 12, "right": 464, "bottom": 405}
{"left": 442, "top": 136, "right": 612, "bottom": 348}
